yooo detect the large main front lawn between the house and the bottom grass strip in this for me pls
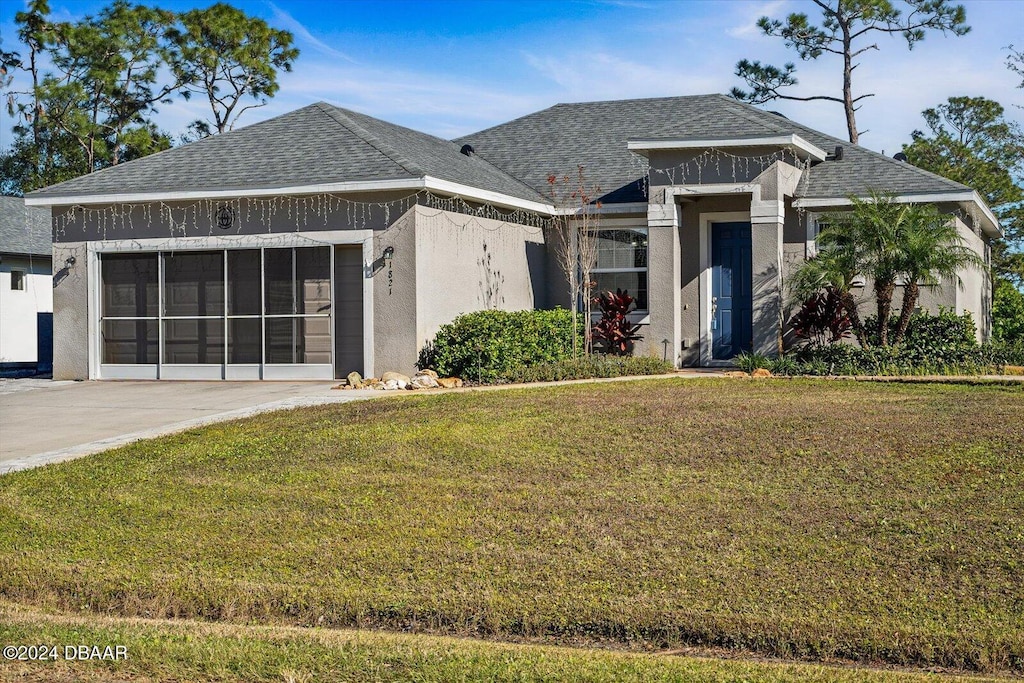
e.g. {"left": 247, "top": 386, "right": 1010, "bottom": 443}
{"left": 0, "top": 380, "right": 1024, "bottom": 672}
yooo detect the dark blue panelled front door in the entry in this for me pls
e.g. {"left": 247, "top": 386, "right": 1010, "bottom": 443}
{"left": 711, "top": 223, "right": 753, "bottom": 360}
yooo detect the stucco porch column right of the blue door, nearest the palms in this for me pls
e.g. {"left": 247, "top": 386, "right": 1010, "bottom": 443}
{"left": 751, "top": 199, "right": 785, "bottom": 358}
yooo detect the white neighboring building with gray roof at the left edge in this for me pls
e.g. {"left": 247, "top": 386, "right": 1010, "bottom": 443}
{"left": 0, "top": 197, "right": 53, "bottom": 376}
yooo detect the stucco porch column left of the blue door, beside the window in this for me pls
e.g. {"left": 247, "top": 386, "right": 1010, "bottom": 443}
{"left": 643, "top": 200, "right": 682, "bottom": 368}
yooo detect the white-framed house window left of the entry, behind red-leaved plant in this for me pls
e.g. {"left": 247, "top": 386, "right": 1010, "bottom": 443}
{"left": 591, "top": 227, "right": 647, "bottom": 311}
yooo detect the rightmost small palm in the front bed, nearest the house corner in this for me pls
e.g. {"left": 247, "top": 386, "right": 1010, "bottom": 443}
{"left": 887, "top": 205, "right": 986, "bottom": 346}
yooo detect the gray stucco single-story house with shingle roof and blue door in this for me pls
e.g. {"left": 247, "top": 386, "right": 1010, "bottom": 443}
{"left": 27, "top": 95, "right": 999, "bottom": 379}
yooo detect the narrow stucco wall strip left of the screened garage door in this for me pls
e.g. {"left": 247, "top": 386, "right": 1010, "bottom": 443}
{"left": 53, "top": 242, "right": 90, "bottom": 380}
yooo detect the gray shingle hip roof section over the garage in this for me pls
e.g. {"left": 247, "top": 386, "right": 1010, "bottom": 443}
{"left": 30, "top": 102, "right": 543, "bottom": 201}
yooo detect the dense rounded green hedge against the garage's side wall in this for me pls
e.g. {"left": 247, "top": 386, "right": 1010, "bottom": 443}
{"left": 417, "top": 308, "right": 584, "bottom": 383}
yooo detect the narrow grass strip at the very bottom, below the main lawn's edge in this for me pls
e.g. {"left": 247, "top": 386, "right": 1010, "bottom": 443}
{"left": 0, "top": 604, "right": 995, "bottom": 683}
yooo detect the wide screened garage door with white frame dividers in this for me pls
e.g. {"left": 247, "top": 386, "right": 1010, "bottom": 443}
{"left": 99, "top": 246, "right": 354, "bottom": 379}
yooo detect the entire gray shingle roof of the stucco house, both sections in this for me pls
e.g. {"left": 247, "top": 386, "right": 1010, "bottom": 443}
{"left": 29, "top": 94, "right": 971, "bottom": 216}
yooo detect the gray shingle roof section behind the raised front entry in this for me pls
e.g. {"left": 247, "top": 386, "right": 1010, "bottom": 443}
{"left": 456, "top": 95, "right": 970, "bottom": 202}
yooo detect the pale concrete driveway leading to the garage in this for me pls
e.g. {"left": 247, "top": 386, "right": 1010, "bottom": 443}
{"left": 0, "top": 379, "right": 381, "bottom": 474}
